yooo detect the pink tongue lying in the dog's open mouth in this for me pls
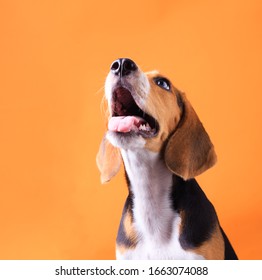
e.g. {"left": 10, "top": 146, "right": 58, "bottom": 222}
{"left": 108, "top": 116, "right": 145, "bottom": 132}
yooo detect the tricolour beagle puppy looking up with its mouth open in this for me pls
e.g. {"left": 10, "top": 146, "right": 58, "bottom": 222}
{"left": 97, "top": 58, "right": 237, "bottom": 259}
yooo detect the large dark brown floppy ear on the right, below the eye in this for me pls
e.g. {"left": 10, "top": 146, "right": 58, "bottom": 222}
{"left": 164, "top": 95, "right": 217, "bottom": 180}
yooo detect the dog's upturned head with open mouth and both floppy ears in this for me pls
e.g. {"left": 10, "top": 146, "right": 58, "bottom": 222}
{"left": 97, "top": 58, "right": 216, "bottom": 182}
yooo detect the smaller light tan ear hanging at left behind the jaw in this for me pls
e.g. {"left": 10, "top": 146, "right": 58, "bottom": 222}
{"left": 96, "top": 136, "right": 121, "bottom": 184}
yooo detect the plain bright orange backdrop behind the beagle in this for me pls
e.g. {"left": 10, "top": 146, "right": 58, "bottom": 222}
{"left": 0, "top": 0, "right": 262, "bottom": 259}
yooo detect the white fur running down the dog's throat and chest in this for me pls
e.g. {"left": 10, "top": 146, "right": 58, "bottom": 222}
{"left": 117, "top": 149, "right": 203, "bottom": 259}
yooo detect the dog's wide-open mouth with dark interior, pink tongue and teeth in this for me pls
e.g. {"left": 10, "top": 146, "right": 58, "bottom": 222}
{"left": 108, "top": 86, "right": 159, "bottom": 138}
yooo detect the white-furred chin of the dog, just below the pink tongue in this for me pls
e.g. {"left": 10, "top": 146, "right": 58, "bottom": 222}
{"left": 106, "top": 131, "right": 146, "bottom": 150}
